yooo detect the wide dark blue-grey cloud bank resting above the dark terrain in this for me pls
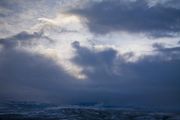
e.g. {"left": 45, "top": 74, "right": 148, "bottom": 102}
{"left": 0, "top": 31, "right": 180, "bottom": 109}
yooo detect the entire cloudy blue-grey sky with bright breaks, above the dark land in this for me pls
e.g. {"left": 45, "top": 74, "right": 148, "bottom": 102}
{"left": 0, "top": 0, "right": 180, "bottom": 109}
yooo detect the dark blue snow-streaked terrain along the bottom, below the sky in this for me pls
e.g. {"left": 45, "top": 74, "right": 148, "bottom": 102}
{"left": 0, "top": 102, "right": 180, "bottom": 120}
